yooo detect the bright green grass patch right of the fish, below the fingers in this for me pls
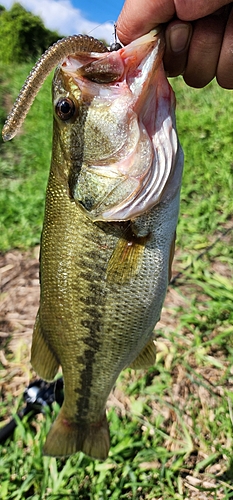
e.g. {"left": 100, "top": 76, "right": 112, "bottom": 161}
{"left": 174, "top": 79, "right": 233, "bottom": 253}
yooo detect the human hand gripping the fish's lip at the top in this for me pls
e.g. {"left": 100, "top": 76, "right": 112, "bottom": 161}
{"left": 117, "top": 0, "right": 233, "bottom": 89}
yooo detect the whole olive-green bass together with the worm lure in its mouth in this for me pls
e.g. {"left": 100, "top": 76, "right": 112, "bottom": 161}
{"left": 3, "top": 27, "right": 184, "bottom": 460}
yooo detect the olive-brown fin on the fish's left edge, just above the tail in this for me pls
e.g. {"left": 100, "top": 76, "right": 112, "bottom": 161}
{"left": 31, "top": 313, "right": 59, "bottom": 380}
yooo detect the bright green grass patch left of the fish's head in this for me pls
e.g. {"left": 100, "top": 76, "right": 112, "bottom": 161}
{"left": 0, "top": 64, "right": 52, "bottom": 251}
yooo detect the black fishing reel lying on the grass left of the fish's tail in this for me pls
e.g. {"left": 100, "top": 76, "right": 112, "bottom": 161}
{"left": 0, "top": 377, "right": 64, "bottom": 444}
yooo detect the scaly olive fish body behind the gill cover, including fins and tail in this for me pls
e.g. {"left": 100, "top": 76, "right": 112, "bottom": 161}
{"left": 32, "top": 166, "right": 179, "bottom": 459}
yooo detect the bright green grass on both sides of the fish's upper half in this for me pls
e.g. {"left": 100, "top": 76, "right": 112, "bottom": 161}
{"left": 0, "top": 65, "right": 233, "bottom": 253}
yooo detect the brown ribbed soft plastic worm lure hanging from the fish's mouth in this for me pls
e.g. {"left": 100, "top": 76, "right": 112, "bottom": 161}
{"left": 2, "top": 35, "right": 108, "bottom": 141}
